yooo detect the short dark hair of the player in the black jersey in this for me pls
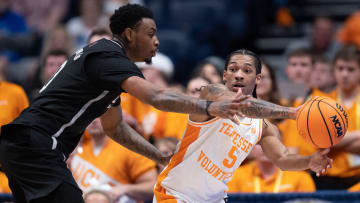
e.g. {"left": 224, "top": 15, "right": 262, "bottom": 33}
{"left": 110, "top": 4, "right": 154, "bottom": 35}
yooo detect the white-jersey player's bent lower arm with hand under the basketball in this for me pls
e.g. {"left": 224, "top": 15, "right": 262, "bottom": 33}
{"left": 260, "top": 120, "right": 332, "bottom": 176}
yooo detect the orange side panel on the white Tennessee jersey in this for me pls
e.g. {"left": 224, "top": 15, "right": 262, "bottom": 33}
{"left": 154, "top": 125, "right": 201, "bottom": 203}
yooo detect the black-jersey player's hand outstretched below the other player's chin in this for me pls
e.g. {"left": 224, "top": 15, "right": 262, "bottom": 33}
{"left": 208, "top": 91, "right": 251, "bottom": 124}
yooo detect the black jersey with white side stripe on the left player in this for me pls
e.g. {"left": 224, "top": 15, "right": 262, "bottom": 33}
{"left": 12, "top": 39, "right": 144, "bottom": 156}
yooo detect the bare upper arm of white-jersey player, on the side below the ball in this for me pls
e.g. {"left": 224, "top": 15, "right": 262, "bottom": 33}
{"left": 260, "top": 119, "right": 288, "bottom": 163}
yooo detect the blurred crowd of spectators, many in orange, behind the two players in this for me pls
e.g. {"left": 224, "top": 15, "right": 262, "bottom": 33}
{"left": 0, "top": 0, "right": 360, "bottom": 202}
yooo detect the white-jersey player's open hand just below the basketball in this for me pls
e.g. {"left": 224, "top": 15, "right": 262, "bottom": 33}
{"left": 309, "top": 148, "right": 333, "bottom": 177}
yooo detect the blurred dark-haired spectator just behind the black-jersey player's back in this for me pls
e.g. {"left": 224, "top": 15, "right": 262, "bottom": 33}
{"left": 28, "top": 49, "right": 69, "bottom": 101}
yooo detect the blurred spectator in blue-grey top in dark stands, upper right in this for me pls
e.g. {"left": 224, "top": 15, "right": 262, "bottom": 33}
{"left": 285, "top": 16, "right": 340, "bottom": 59}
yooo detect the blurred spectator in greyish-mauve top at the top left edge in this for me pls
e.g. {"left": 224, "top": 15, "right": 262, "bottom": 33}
{"left": 12, "top": 0, "right": 69, "bottom": 35}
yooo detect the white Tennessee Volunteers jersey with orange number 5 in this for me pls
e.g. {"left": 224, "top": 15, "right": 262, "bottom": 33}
{"left": 154, "top": 118, "right": 262, "bottom": 202}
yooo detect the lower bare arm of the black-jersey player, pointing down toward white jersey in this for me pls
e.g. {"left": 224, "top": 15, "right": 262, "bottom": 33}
{"left": 100, "top": 107, "right": 170, "bottom": 165}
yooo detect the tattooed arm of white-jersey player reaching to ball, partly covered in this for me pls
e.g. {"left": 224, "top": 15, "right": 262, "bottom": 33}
{"left": 201, "top": 84, "right": 298, "bottom": 120}
